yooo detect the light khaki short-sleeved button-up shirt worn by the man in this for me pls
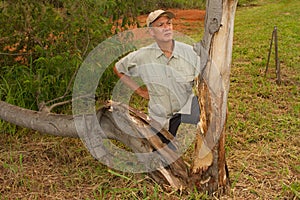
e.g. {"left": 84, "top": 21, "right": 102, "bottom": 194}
{"left": 116, "top": 41, "right": 200, "bottom": 124}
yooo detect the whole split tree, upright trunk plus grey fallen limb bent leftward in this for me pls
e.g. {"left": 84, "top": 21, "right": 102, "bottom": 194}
{"left": 0, "top": 0, "right": 237, "bottom": 193}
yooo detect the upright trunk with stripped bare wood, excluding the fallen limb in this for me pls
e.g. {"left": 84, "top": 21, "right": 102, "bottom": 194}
{"left": 191, "top": 0, "right": 237, "bottom": 192}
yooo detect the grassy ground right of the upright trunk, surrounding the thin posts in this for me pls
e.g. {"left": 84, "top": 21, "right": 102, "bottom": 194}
{"left": 227, "top": 1, "right": 300, "bottom": 199}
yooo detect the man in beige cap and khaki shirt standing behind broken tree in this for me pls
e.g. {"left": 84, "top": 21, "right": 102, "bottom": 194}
{"left": 114, "top": 10, "right": 200, "bottom": 139}
